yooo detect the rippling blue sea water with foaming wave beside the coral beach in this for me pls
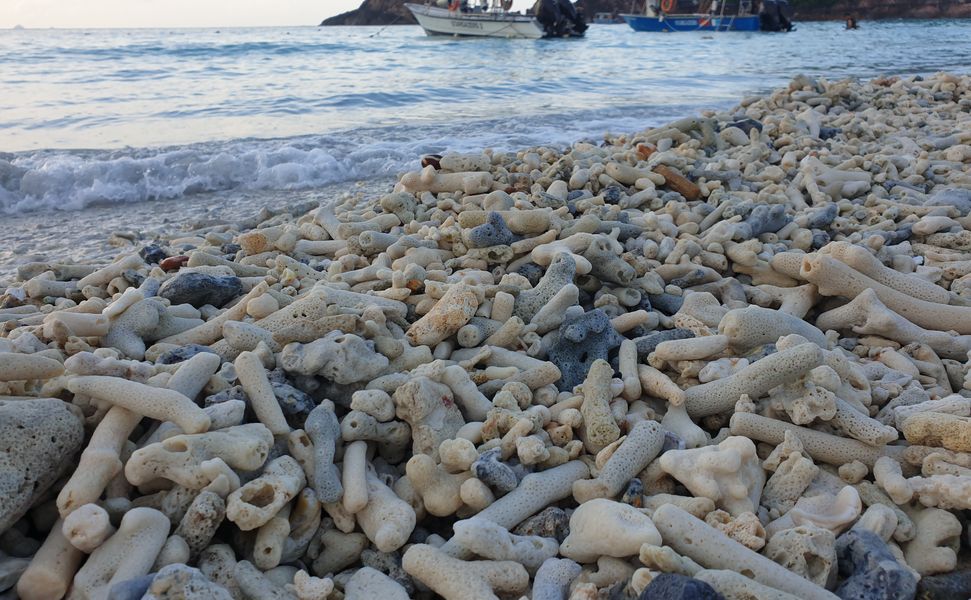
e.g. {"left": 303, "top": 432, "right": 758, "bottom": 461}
{"left": 0, "top": 21, "right": 971, "bottom": 214}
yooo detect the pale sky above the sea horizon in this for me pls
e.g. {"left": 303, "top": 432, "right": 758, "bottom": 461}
{"left": 0, "top": 0, "right": 532, "bottom": 29}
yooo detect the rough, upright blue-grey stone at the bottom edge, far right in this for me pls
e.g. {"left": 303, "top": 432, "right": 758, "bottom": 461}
{"left": 835, "top": 529, "right": 917, "bottom": 600}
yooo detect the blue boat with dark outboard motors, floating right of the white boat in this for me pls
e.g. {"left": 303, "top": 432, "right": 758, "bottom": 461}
{"left": 620, "top": 0, "right": 792, "bottom": 32}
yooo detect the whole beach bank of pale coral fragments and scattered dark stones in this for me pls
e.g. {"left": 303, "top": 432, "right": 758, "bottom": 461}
{"left": 0, "top": 74, "right": 971, "bottom": 600}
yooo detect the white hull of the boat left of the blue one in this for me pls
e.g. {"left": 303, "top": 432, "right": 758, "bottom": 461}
{"left": 405, "top": 4, "right": 544, "bottom": 40}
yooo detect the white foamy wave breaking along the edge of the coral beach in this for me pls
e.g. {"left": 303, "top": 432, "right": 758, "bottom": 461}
{"left": 0, "top": 110, "right": 683, "bottom": 215}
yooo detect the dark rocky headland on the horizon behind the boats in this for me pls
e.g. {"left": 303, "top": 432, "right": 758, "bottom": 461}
{"left": 321, "top": 0, "right": 971, "bottom": 26}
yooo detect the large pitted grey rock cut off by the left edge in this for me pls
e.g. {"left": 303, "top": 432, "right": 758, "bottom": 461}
{"left": 0, "top": 398, "right": 84, "bottom": 532}
